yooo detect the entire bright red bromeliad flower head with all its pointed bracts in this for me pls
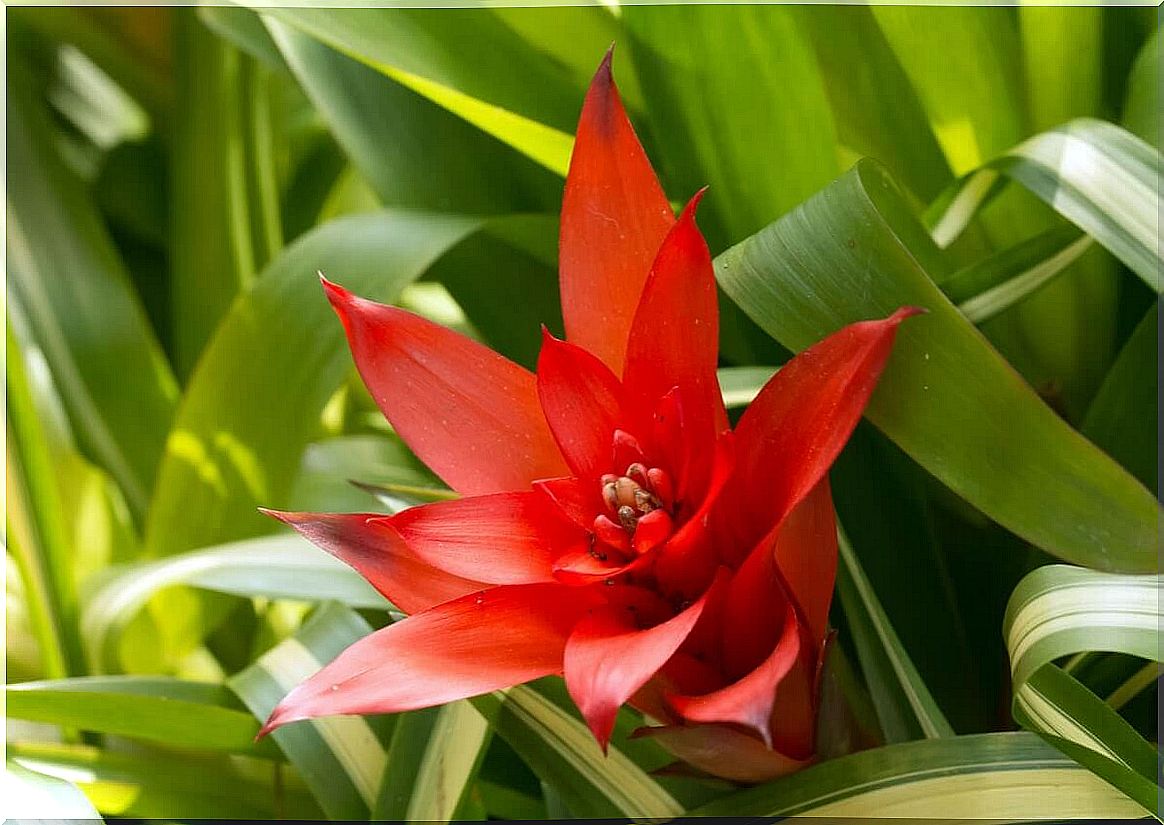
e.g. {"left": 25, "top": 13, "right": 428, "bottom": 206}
{"left": 263, "top": 55, "right": 917, "bottom": 781}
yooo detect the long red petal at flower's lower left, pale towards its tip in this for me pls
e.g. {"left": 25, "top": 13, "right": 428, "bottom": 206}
{"left": 263, "top": 584, "right": 598, "bottom": 733}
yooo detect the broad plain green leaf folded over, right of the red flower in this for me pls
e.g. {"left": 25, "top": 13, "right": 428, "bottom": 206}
{"left": 716, "top": 162, "right": 1159, "bottom": 571}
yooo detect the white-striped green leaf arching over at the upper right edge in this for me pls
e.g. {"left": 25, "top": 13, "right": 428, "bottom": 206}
{"left": 934, "top": 119, "right": 1164, "bottom": 292}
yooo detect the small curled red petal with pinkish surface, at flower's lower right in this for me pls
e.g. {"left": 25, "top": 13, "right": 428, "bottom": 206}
{"left": 667, "top": 604, "right": 801, "bottom": 747}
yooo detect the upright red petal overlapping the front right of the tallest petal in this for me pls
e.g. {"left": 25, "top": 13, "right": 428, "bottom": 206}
{"left": 623, "top": 192, "right": 728, "bottom": 486}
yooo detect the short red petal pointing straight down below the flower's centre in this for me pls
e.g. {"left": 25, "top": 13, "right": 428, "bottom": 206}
{"left": 565, "top": 570, "right": 724, "bottom": 751}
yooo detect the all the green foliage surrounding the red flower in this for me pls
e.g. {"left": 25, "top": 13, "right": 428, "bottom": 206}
{"left": 6, "top": 5, "right": 1161, "bottom": 820}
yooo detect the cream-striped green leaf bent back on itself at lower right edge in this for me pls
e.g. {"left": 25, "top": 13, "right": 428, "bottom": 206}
{"left": 1003, "top": 564, "right": 1164, "bottom": 810}
